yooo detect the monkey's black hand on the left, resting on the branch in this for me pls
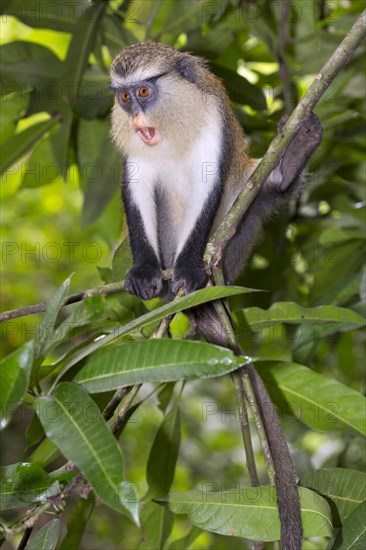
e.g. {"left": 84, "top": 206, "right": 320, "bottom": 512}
{"left": 125, "top": 265, "right": 163, "bottom": 300}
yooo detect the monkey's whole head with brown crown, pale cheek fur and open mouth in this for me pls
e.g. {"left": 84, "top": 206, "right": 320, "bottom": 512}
{"left": 110, "top": 43, "right": 212, "bottom": 155}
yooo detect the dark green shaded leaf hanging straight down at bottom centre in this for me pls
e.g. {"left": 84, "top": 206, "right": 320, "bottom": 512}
{"left": 145, "top": 406, "right": 181, "bottom": 499}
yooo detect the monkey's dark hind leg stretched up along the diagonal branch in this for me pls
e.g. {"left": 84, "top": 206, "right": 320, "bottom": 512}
{"left": 223, "top": 113, "right": 323, "bottom": 282}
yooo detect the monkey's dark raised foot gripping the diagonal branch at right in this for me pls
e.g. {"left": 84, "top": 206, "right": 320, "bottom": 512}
{"left": 279, "top": 113, "right": 323, "bottom": 193}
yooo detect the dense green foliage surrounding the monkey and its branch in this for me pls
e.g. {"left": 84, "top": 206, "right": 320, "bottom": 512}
{"left": 0, "top": 0, "right": 366, "bottom": 550}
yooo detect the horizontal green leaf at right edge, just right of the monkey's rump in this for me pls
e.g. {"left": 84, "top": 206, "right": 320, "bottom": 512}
{"left": 237, "top": 302, "right": 365, "bottom": 330}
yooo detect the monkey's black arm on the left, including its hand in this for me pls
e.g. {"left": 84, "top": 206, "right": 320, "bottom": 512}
{"left": 122, "top": 182, "right": 163, "bottom": 300}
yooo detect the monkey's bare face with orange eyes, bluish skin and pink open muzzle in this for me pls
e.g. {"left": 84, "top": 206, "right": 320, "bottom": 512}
{"left": 111, "top": 79, "right": 160, "bottom": 146}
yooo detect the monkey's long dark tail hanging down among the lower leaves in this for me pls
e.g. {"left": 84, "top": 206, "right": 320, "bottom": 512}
{"left": 191, "top": 304, "right": 302, "bottom": 550}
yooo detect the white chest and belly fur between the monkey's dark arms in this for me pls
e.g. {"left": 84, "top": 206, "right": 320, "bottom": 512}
{"left": 127, "top": 122, "right": 222, "bottom": 267}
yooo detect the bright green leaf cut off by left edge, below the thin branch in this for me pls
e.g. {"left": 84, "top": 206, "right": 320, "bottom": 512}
{"left": 0, "top": 342, "right": 33, "bottom": 429}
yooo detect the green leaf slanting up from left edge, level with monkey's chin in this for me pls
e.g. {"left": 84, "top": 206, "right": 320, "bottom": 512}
{"left": 0, "top": 117, "right": 58, "bottom": 175}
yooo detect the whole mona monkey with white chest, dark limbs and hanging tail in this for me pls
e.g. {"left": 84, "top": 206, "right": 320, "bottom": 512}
{"left": 110, "top": 42, "right": 321, "bottom": 550}
